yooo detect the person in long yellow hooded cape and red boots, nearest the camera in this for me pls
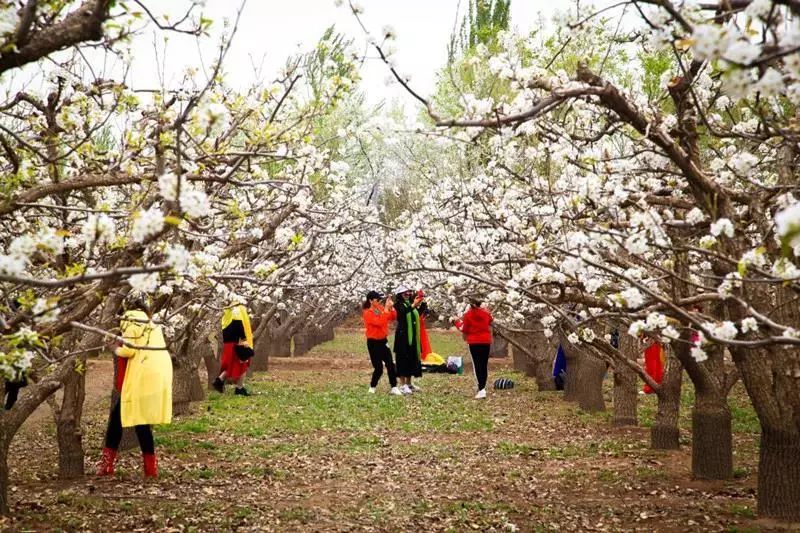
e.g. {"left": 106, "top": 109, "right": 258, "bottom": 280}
{"left": 97, "top": 296, "right": 172, "bottom": 478}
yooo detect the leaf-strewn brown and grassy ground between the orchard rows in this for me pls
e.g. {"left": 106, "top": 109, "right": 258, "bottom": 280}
{"left": 0, "top": 330, "right": 768, "bottom": 531}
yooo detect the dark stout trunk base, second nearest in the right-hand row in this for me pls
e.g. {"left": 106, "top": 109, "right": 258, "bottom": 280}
{"left": 692, "top": 402, "right": 733, "bottom": 479}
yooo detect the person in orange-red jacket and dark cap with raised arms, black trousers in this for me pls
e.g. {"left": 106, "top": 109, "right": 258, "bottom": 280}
{"left": 362, "top": 291, "right": 401, "bottom": 396}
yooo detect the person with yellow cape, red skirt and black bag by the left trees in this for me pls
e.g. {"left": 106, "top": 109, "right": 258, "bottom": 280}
{"left": 214, "top": 304, "right": 253, "bottom": 396}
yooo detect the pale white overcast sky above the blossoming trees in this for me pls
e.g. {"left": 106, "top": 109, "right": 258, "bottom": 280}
{"left": 126, "top": 0, "right": 592, "bottom": 108}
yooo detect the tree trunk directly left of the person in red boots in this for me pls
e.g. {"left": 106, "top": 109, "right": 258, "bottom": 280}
{"left": 55, "top": 366, "right": 86, "bottom": 479}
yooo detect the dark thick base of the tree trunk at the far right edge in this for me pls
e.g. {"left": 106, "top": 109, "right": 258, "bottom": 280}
{"left": 758, "top": 426, "right": 800, "bottom": 522}
